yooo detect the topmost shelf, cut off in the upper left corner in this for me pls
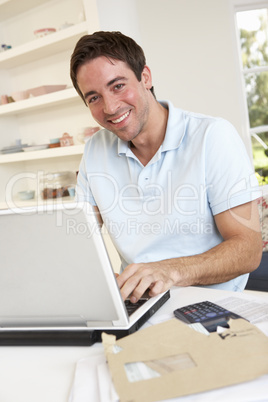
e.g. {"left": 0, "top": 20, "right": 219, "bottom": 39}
{"left": 0, "top": 0, "right": 47, "bottom": 21}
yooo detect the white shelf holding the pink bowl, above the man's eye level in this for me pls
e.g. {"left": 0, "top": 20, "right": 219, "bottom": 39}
{"left": 0, "top": 22, "right": 87, "bottom": 68}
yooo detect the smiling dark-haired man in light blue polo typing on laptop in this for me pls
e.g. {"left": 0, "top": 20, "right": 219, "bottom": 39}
{"left": 71, "top": 32, "right": 262, "bottom": 302}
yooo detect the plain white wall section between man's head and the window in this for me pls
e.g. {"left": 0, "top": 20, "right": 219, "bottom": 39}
{"left": 136, "top": 0, "right": 251, "bottom": 153}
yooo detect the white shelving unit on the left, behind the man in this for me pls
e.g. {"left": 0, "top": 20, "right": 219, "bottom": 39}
{"left": 0, "top": 0, "right": 99, "bottom": 209}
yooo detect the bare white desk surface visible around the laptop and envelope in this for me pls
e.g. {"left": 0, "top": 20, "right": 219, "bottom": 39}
{"left": 0, "top": 287, "right": 268, "bottom": 402}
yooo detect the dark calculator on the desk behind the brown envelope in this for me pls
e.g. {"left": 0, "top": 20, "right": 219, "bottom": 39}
{"left": 174, "top": 301, "right": 243, "bottom": 332}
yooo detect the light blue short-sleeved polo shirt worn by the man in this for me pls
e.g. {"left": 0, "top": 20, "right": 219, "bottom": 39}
{"left": 77, "top": 102, "right": 260, "bottom": 290}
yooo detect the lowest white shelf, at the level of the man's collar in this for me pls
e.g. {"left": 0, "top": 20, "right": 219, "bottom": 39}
{"left": 0, "top": 144, "right": 84, "bottom": 164}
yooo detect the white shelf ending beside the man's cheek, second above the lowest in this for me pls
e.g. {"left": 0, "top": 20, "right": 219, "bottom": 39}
{"left": 0, "top": 88, "right": 80, "bottom": 117}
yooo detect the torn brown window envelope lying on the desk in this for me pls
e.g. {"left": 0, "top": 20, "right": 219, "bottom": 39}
{"left": 103, "top": 319, "right": 268, "bottom": 402}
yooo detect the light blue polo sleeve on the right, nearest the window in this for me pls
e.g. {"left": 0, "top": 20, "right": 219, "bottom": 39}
{"left": 205, "top": 119, "right": 260, "bottom": 215}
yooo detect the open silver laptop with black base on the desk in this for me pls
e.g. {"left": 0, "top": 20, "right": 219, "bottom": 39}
{"left": 0, "top": 203, "right": 169, "bottom": 345}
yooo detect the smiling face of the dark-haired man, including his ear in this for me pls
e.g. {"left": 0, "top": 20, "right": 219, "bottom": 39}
{"left": 77, "top": 56, "right": 152, "bottom": 141}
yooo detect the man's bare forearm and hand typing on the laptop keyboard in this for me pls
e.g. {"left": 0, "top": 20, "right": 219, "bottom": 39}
{"left": 117, "top": 233, "right": 262, "bottom": 302}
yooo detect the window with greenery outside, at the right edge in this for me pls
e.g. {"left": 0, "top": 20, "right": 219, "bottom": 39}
{"left": 236, "top": 2, "right": 268, "bottom": 184}
